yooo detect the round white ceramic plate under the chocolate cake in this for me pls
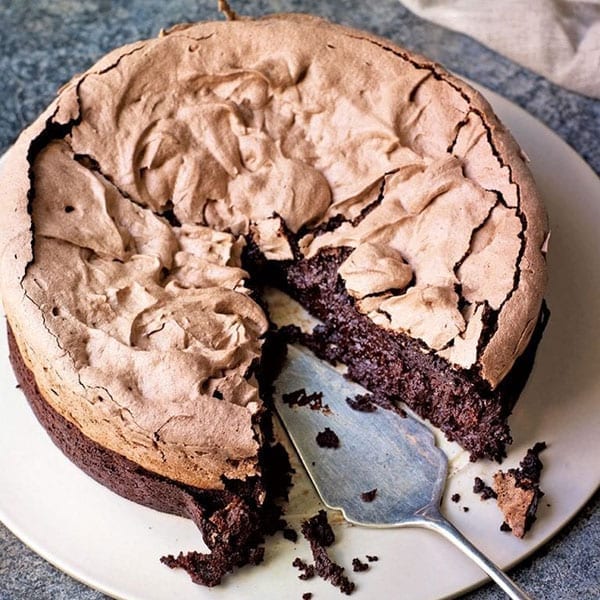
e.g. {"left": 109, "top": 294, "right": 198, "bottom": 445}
{"left": 0, "top": 83, "right": 600, "bottom": 600}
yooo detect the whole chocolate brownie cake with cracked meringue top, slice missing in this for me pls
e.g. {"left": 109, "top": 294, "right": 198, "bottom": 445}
{"left": 0, "top": 15, "right": 547, "bottom": 584}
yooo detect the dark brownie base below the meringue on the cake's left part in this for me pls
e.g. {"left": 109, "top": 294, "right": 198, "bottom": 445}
{"left": 8, "top": 325, "right": 290, "bottom": 586}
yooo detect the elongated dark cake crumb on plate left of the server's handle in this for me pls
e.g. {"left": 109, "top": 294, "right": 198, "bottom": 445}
{"left": 294, "top": 510, "right": 355, "bottom": 595}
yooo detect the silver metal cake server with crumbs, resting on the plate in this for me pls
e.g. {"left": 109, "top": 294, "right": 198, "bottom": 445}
{"left": 275, "top": 346, "right": 530, "bottom": 600}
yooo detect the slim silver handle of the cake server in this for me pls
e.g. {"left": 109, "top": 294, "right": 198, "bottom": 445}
{"left": 414, "top": 505, "right": 533, "bottom": 600}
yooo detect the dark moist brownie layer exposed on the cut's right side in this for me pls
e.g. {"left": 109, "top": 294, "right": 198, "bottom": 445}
{"left": 248, "top": 248, "right": 548, "bottom": 461}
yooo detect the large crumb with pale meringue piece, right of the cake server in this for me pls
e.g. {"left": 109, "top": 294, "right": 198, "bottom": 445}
{"left": 494, "top": 442, "right": 546, "bottom": 538}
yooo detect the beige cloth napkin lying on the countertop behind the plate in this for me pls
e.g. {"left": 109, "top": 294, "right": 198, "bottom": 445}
{"left": 401, "top": 0, "right": 600, "bottom": 98}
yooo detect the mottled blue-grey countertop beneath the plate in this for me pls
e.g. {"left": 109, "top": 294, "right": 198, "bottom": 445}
{"left": 0, "top": 0, "right": 600, "bottom": 600}
